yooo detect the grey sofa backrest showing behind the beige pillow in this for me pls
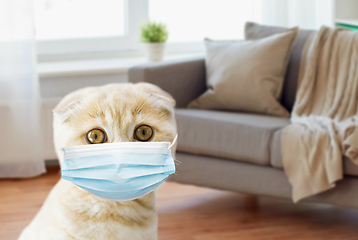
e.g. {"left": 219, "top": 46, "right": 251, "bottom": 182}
{"left": 245, "top": 22, "right": 314, "bottom": 112}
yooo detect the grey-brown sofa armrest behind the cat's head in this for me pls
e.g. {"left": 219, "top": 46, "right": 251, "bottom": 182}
{"left": 128, "top": 58, "right": 206, "bottom": 108}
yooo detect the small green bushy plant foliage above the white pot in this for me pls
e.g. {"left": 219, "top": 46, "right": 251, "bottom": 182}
{"left": 141, "top": 22, "right": 168, "bottom": 43}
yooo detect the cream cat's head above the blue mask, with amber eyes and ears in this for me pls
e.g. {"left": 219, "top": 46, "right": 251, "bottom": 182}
{"left": 54, "top": 83, "right": 176, "bottom": 165}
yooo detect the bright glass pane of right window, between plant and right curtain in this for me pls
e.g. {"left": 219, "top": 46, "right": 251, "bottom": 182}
{"left": 149, "top": 0, "right": 261, "bottom": 42}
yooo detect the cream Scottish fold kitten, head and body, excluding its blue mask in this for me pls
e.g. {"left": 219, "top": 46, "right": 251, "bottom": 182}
{"left": 19, "top": 83, "right": 176, "bottom": 240}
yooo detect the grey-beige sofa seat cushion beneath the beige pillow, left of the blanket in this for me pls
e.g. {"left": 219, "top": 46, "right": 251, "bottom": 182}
{"left": 175, "top": 109, "right": 290, "bottom": 165}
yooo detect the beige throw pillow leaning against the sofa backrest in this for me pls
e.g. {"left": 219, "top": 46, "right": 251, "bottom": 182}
{"left": 188, "top": 28, "right": 297, "bottom": 117}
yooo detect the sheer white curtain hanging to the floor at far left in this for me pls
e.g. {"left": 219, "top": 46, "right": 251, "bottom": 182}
{"left": 0, "top": 0, "right": 45, "bottom": 178}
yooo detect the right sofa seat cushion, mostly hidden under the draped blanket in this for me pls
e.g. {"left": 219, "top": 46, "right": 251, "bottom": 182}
{"left": 270, "top": 129, "right": 358, "bottom": 176}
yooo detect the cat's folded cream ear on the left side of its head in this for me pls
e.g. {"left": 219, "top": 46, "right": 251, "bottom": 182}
{"left": 52, "top": 88, "right": 92, "bottom": 114}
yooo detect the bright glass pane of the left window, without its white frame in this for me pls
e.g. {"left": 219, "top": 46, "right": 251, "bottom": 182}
{"left": 35, "top": 0, "right": 125, "bottom": 40}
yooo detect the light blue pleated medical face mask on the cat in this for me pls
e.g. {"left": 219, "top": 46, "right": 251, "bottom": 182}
{"left": 61, "top": 137, "right": 177, "bottom": 201}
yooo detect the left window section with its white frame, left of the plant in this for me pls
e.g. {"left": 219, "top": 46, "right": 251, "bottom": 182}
{"left": 34, "top": 0, "right": 148, "bottom": 59}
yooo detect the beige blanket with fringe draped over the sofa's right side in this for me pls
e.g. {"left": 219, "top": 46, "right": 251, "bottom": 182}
{"left": 281, "top": 27, "right": 358, "bottom": 202}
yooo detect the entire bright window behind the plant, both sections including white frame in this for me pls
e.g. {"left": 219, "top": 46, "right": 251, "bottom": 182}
{"left": 34, "top": 0, "right": 262, "bottom": 59}
